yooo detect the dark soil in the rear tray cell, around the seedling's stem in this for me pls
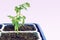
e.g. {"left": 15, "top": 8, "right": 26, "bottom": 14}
{"left": 3, "top": 25, "right": 36, "bottom": 31}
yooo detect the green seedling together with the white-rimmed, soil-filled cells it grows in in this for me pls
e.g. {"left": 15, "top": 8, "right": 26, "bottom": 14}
{"left": 0, "top": 2, "right": 41, "bottom": 40}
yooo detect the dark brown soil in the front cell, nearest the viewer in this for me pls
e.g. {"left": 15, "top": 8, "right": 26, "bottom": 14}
{"left": 0, "top": 33, "right": 38, "bottom": 40}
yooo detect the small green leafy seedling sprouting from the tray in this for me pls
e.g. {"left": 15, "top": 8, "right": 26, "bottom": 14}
{"left": 8, "top": 2, "right": 30, "bottom": 31}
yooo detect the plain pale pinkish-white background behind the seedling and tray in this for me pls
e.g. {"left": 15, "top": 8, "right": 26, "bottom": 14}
{"left": 0, "top": 0, "right": 60, "bottom": 40}
